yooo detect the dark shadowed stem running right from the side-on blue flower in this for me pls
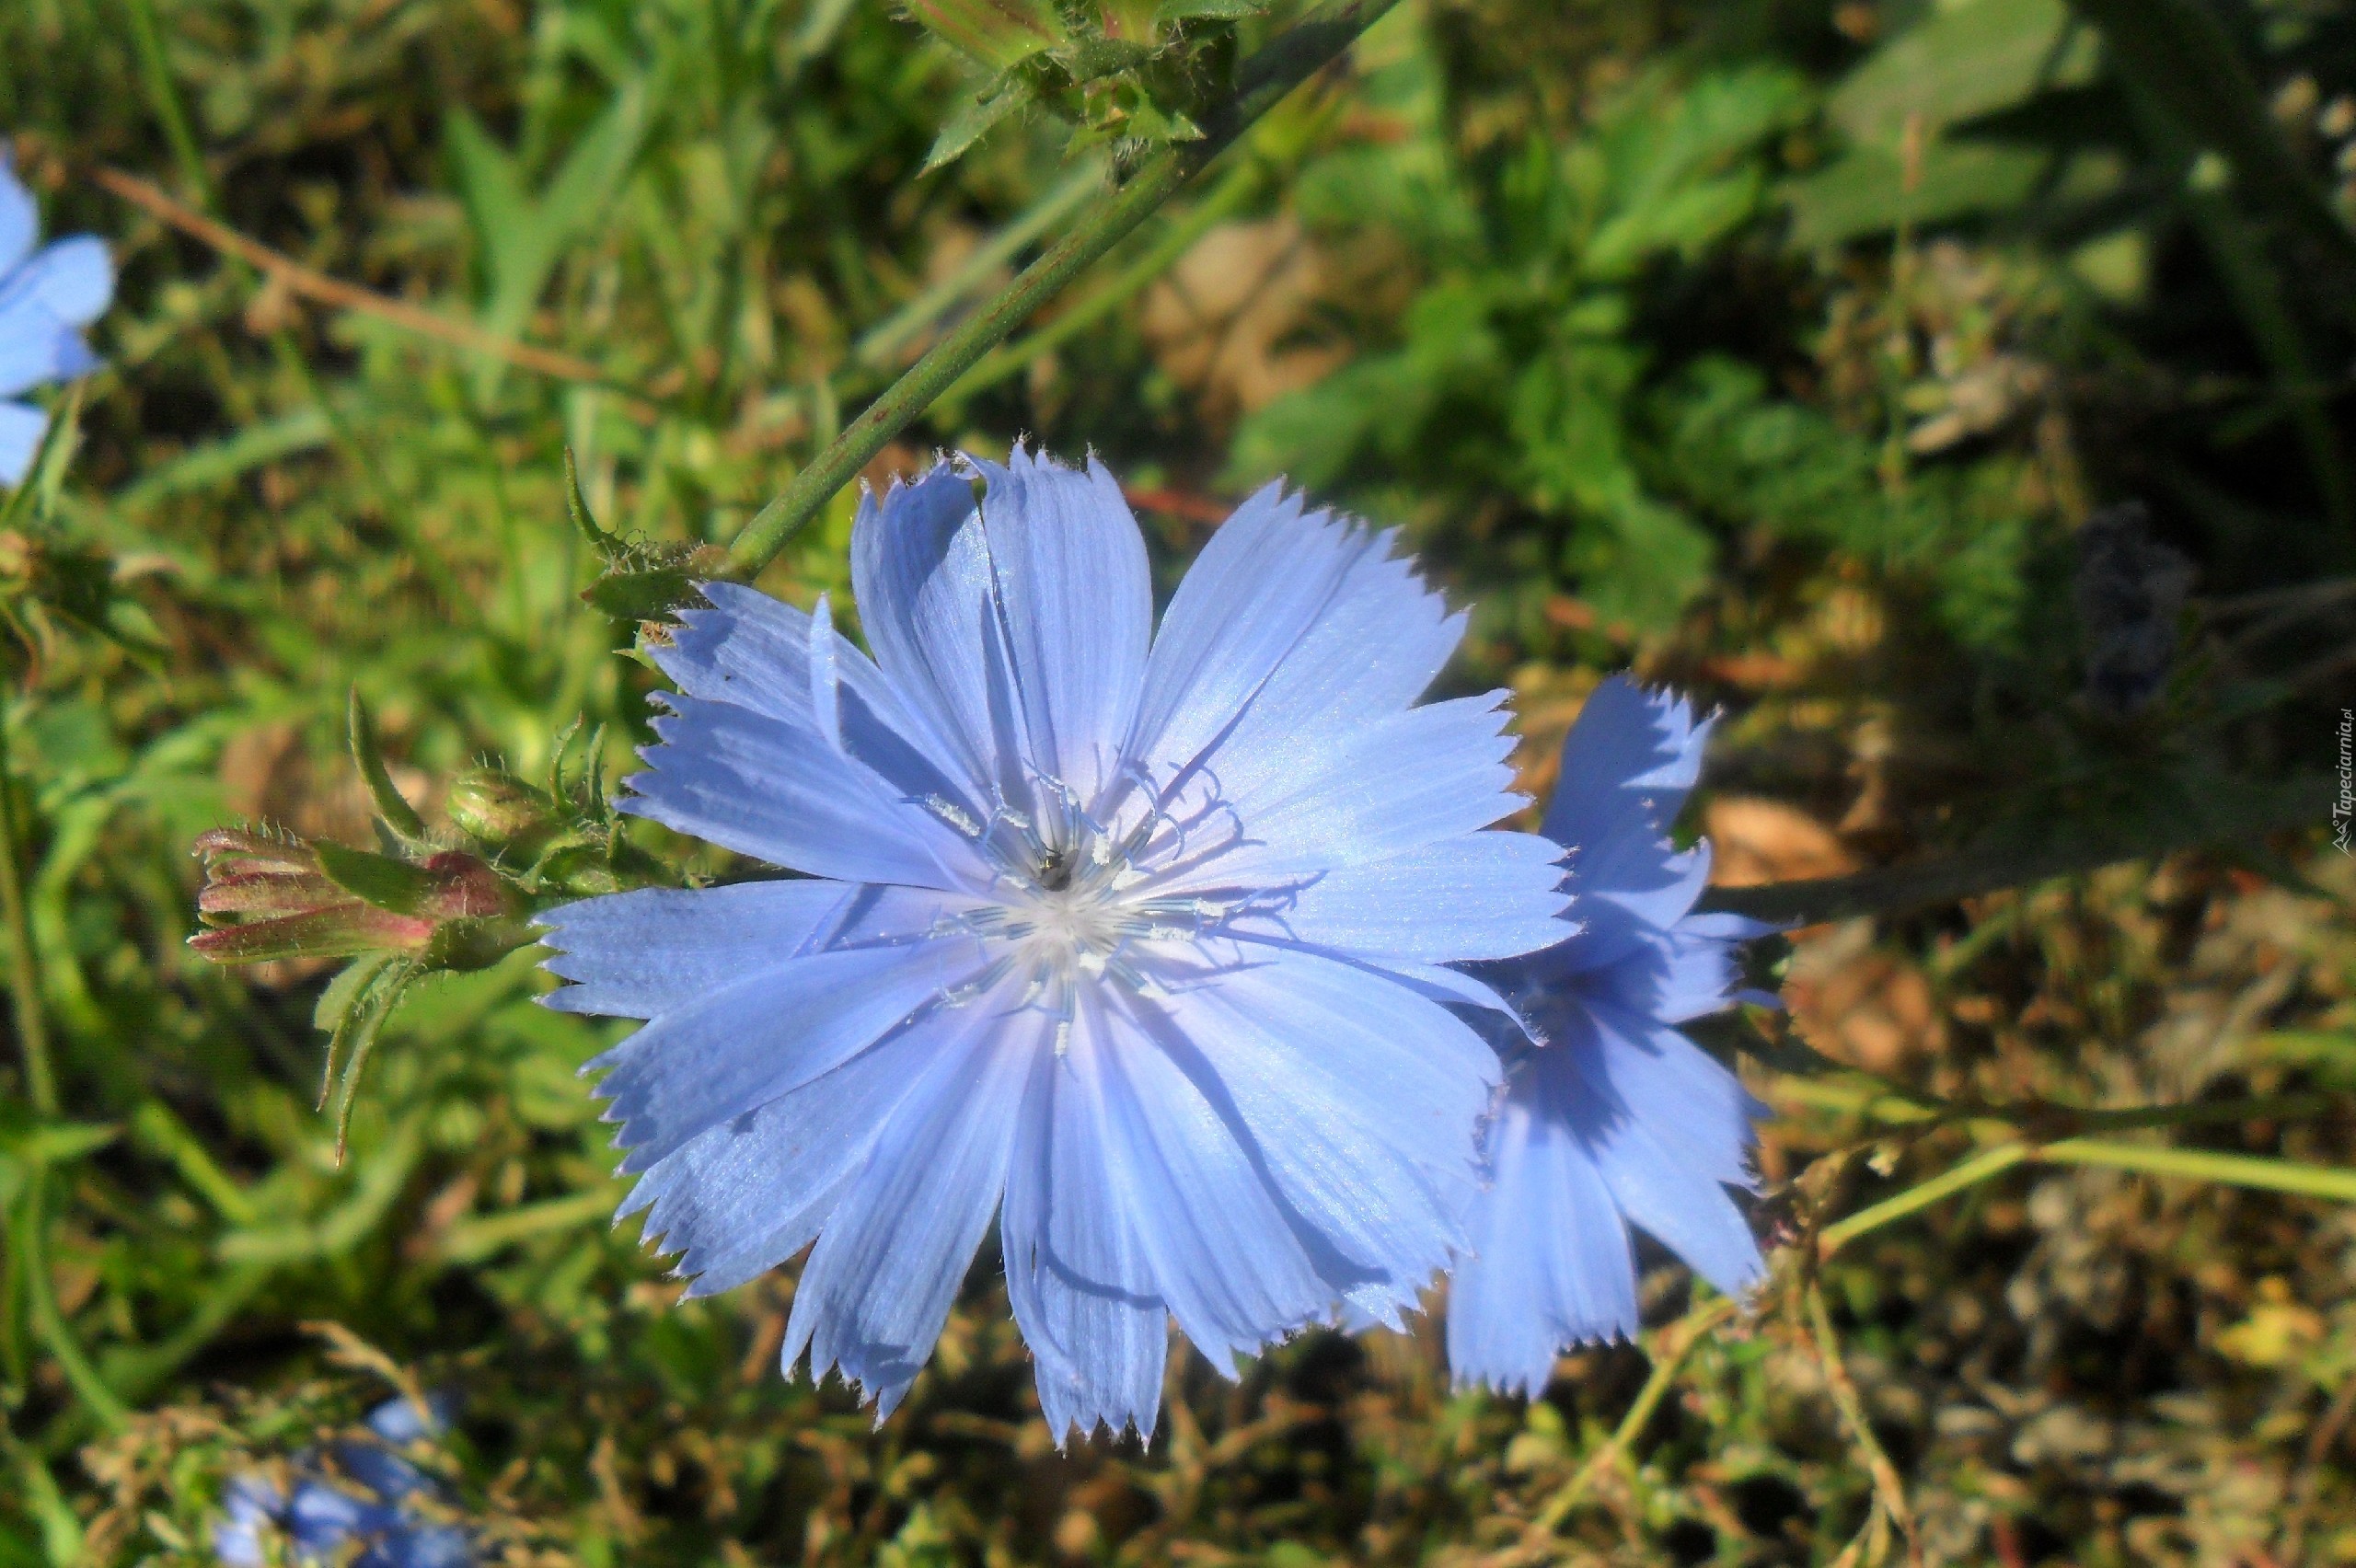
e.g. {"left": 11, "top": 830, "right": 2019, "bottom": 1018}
{"left": 1699, "top": 779, "right": 2335, "bottom": 926}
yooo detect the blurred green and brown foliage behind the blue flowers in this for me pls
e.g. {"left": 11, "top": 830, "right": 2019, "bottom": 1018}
{"left": 0, "top": 0, "right": 2356, "bottom": 1568}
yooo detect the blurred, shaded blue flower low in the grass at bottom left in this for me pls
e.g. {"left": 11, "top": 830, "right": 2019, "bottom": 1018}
{"left": 212, "top": 1399, "right": 474, "bottom": 1568}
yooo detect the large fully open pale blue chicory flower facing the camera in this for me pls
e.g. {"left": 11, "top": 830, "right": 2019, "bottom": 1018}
{"left": 547, "top": 450, "right": 1562, "bottom": 1438}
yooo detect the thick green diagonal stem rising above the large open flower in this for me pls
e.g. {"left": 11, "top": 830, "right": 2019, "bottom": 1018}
{"left": 728, "top": 0, "right": 1397, "bottom": 579}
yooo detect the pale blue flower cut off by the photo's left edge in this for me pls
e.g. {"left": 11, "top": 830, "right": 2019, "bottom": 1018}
{"left": 0, "top": 148, "right": 115, "bottom": 485}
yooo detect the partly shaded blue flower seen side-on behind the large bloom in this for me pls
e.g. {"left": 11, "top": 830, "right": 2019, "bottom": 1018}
{"left": 1449, "top": 678, "right": 1774, "bottom": 1394}
